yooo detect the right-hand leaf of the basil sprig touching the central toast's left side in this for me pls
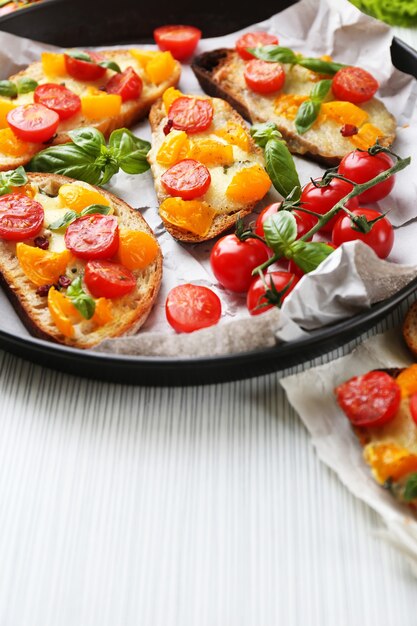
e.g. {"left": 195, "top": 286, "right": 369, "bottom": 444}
{"left": 109, "top": 128, "right": 151, "bottom": 174}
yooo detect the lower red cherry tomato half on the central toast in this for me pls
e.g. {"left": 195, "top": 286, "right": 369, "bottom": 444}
{"left": 161, "top": 159, "right": 211, "bottom": 200}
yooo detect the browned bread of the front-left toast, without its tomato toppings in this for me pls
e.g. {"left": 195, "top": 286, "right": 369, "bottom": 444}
{"left": 0, "top": 174, "right": 162, "bottom": 348}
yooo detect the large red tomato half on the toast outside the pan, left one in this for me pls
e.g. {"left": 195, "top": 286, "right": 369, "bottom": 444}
{"left": 335, "top": 371, "right": 401, "bottom": 428}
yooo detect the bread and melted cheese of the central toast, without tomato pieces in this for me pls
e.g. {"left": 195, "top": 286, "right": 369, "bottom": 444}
{"left": 148, "top": 96, "right": 270, "bottom": 243}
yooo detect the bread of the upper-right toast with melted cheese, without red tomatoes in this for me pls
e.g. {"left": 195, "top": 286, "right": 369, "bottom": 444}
{"left": 192, "top": 48, "right": 396, "bottom": 166}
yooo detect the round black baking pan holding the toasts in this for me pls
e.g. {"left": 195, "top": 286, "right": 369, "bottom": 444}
{"left": 0, "top": 0, "right": 417, "bottom": 386}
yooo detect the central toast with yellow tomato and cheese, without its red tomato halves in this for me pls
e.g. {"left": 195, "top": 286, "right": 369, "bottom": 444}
{"left": 148, "top": 89, "right": 271, "bottom": 243}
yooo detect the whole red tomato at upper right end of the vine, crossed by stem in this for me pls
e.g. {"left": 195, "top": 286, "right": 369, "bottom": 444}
{"left": 337, "top": 150, "right": 395, "bottom": 203}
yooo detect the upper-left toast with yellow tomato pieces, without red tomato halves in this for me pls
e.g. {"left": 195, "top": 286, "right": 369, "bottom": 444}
{"left": 0, "top": 49, "right": 181, "bottom": 171}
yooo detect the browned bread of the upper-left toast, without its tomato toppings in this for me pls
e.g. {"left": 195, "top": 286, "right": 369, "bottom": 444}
{"left": 0, "top": 49, "right": 181, "bottom": 171}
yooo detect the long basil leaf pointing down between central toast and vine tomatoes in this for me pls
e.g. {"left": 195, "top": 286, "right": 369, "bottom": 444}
{"left": 265, "top": 139, "right": 301, "bottom": 200}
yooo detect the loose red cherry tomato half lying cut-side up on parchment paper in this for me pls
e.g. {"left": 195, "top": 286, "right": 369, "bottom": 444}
{"left": 165, "top": 283, "right": 222, "bottom": 333}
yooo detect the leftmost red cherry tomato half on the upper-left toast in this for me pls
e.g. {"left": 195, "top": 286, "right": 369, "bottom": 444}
{"left": 7, "top": 104, "right": 59, "bottom": 143}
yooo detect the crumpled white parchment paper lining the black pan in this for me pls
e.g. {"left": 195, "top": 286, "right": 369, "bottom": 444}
{"left": 0, "top": 0, "right": 417, "bottom": 355}
